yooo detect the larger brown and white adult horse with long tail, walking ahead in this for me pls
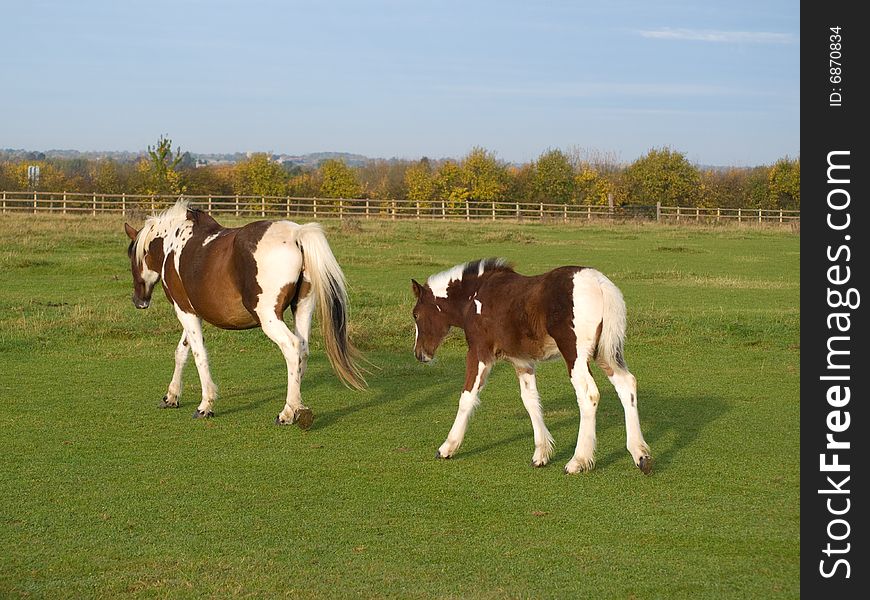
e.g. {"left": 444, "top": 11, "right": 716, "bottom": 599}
{"left": 124, "top": 200, "right": 365, "bottom": 429}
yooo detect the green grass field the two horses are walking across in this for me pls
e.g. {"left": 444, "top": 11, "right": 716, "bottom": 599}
{"left": 0, "top": 215, "right": 800, "bottom": 599}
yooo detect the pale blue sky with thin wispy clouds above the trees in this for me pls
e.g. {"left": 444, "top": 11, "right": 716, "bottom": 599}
{"left": 0, "top": 0, "right": 800, "bottom": 166}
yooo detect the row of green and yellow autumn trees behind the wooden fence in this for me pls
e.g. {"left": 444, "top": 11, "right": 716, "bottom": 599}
{"left": 0, "top": 136, "right": 800, "bottom": 209}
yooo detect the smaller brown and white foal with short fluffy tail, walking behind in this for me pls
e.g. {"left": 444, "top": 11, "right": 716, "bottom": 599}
{"left": 411, "top": 258, "right": 652, "bottom": 474}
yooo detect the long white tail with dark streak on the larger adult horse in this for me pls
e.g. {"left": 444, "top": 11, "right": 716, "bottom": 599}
{"left": 296, "top": 223, "right": 366, "bottom": 389}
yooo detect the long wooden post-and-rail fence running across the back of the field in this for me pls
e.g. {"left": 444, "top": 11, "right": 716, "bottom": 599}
{"left": 0, "top": 192, "right": 800, "bottom": 224}
